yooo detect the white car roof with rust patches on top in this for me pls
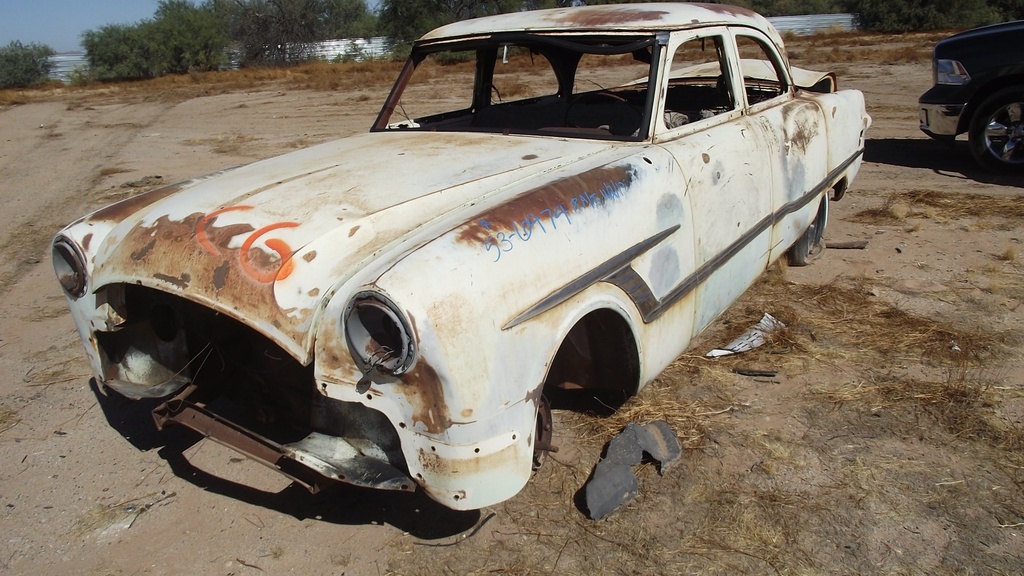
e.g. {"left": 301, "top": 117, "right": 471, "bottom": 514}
{"left": 417, "top": 2, "right": 782, "bottom": 45}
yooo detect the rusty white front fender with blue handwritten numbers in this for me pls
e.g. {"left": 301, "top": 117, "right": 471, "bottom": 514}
{"left": 314, "top": 149, "right": 678, "bottom": 508}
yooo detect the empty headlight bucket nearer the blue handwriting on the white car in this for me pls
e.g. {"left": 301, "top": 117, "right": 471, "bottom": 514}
{"left": 343, "top": 291, "right": 416, "bottom": 375}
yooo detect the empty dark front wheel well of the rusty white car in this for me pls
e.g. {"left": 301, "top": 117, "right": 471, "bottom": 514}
{"left": 544, "top": 308, "right": 640, "bottom": 412}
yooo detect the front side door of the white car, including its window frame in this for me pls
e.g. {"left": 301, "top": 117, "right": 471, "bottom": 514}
{"left": 655, "top": 28, "right": 772, "bottom": 333}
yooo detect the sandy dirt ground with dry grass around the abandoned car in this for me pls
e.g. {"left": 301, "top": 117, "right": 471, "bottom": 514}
{"left": 0, "top": 39, "right": 1024, "bottom": 576}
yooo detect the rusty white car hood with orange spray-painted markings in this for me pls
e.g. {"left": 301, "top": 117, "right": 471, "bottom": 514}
{"left": 83, "top": 132, "right": 610, "bottom": 361}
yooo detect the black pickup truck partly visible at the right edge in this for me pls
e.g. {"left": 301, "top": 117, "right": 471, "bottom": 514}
{"left": 919, "top": 20, "right": 1024, "bottom": 174}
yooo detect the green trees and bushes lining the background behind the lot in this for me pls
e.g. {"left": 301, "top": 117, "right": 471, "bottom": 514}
{"left": 0, "top": 0, "right": 1024, "bottom": 88}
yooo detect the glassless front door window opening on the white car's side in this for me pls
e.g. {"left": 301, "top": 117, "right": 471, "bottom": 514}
{"left": 665, "top": 36, "right": 737, "bottom": 129}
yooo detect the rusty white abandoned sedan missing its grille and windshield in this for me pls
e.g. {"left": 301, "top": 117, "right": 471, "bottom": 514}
{"left": 52, "top": 3, "right": 870, "bottom": 509}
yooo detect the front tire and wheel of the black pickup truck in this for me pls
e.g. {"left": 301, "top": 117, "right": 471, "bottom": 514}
{"left": 968, "top": 86, "right": 1024, "bottom": 174}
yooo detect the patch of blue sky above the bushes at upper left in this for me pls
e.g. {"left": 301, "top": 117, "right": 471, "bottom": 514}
{"left": 0, "top": 0, "right": 166, "bottom": 52}
